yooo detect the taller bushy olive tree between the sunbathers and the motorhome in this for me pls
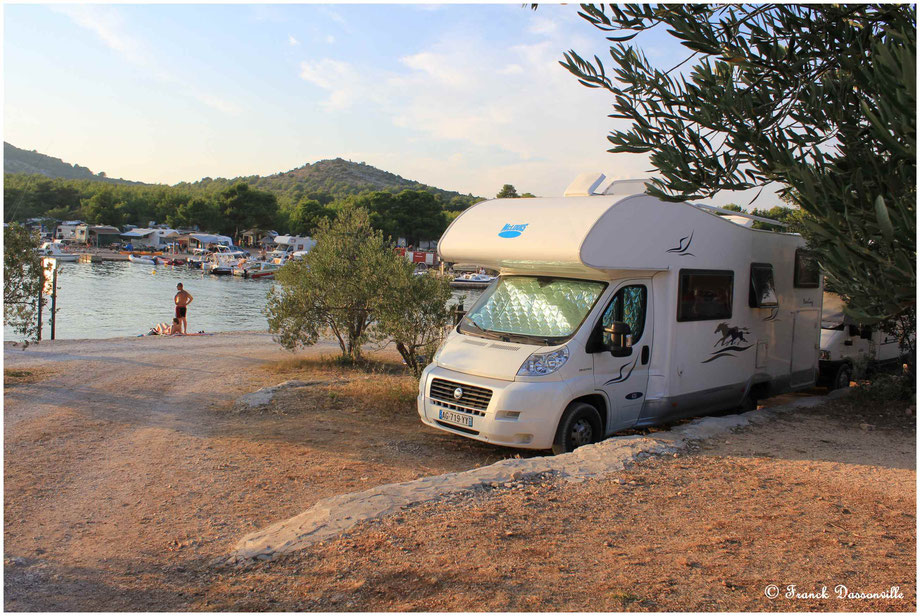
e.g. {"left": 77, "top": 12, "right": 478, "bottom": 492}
{"left": 265, "top": 207, "right": 396, "bottom": 362}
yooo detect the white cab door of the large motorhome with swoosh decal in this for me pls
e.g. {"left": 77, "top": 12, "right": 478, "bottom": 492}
{"left": 589, "top": 280, "right": 653, "bottom": 434}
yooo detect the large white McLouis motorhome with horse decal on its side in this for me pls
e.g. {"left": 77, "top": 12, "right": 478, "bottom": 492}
{"left": 418, "top": 176, "right": 823, "bottom": 452}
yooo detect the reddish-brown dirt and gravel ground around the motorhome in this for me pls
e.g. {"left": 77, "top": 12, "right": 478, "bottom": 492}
{"left": 4, "top": 334, "right": 916, "bottom": 611}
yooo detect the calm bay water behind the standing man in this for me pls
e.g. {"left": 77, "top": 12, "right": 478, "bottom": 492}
{"left": 4, "top": 261, "right": 481, "bottom": 340}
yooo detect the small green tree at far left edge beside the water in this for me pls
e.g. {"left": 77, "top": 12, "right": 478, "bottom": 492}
{"left": 3, "top": 223, "right": 45, "bottom": 341}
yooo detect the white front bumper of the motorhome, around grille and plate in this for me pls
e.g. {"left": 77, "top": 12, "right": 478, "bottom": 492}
{"left": 418, "top": 364, "right": 569, "bottom": 449}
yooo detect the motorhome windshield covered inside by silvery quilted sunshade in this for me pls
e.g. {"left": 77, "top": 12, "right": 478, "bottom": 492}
{"left": 460, "top": 276, "right": 607, "bottom": 345}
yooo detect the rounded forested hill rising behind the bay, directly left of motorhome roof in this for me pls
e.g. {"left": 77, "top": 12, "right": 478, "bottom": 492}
{"left": 177, "top": 158, "right": 472, "bottom": 204}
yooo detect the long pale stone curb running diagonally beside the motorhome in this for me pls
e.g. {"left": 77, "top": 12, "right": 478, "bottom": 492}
{"left": 223, "top": 390, "right": 847, "bottom": 563}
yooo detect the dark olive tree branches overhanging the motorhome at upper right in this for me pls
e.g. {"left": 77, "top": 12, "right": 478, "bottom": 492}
{"left": 561, "top": 4, "right": 917, "bottom": 340}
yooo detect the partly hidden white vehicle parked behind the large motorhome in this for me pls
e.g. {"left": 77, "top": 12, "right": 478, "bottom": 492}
{"left": 818, "top": 293, "right": 902, "bottom": 389}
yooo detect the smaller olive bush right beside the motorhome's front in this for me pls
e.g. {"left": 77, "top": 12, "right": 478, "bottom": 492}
{"left": 375, "top": 264, "right": 450, "bottom": 378}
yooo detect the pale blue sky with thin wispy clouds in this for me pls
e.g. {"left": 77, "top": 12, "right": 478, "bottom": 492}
{"left": 3, "top": 2, "right": 779, "bottom": 207}
